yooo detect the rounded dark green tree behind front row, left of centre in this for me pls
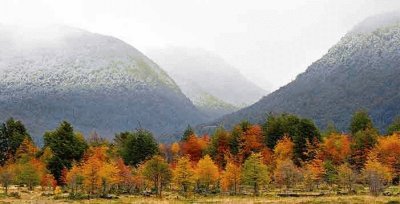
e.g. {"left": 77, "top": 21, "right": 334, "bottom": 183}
{"left": 116, "top": 129, "right": 158, "bottom": 166}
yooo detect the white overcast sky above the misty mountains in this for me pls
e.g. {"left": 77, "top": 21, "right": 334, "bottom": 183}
{"left": 0, "top": 0, "right": 400, "bottom": 90}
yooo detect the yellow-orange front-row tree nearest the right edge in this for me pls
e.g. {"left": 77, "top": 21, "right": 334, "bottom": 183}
{"left": 362, "top": 153, "right": 392, "bottom": 196}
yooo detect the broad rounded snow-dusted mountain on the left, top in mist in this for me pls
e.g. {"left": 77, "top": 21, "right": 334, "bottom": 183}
{"left": 0, "top": 26, "right": 205, "bottom": 139}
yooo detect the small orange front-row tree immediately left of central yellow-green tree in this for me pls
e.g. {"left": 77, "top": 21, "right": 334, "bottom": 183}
{"left": 221, "top": 161, "right": 241, "bottom": 195}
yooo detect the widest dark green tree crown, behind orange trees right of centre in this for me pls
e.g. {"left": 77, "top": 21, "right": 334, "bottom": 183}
{"left": 263, "top": 114, "right": 321, "bottom": 165}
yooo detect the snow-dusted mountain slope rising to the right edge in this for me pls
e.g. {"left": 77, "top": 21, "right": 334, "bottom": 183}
{"left": 209, "top": 14, "right": 400, "bottom": 130}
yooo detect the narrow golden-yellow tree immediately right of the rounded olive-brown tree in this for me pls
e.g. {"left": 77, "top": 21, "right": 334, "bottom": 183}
{"left": 173, "top": 156, "right": 195, "bottom": 193}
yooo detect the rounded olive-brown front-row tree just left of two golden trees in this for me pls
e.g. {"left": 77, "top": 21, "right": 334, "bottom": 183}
{"left": 143, "top": 156, "right": 172, "bottom": 197}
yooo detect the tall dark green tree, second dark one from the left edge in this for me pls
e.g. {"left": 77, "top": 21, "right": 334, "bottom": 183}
{"left": 43, "top": 121, "right": 88, "bottom": 185}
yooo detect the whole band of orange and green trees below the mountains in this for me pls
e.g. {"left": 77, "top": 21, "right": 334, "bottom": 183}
{"left": 0, "top": 110, "right": 400, "bottom": 200}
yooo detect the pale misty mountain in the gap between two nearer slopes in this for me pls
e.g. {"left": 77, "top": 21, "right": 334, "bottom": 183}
{"left": 149, "top": 47, "right": 267, "bottom": 119}
